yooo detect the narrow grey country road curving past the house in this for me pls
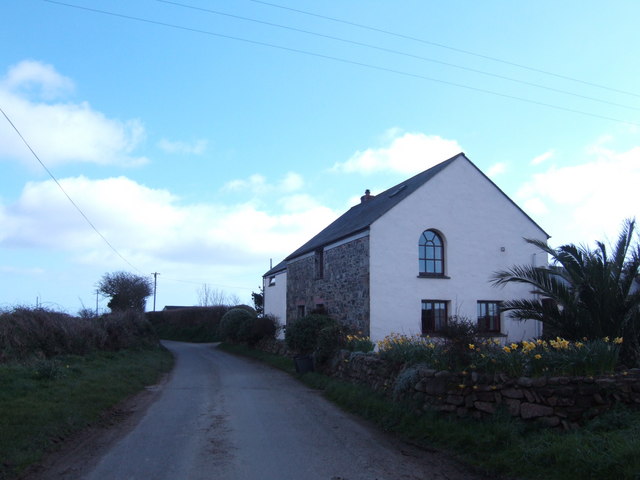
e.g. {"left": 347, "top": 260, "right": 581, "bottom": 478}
{"left": 48, "top": 342, "right": 484, "bottom": 480}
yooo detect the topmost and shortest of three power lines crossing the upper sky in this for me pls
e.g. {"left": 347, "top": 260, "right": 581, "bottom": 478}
{"left": 248, "top": 0, "right": 640, "bottom": 97}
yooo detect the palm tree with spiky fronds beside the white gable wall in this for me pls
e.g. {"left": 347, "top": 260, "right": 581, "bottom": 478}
{"left": 492, "top": 219, "right": 640, "bottom": 363}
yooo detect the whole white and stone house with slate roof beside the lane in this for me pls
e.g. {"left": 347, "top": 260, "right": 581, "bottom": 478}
{"left": 263, "top": 153, "right": 549, "bottom": 341}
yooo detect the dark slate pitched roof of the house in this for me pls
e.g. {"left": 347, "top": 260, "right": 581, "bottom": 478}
{"left": 272, "top": 152, "right": 549, "bottom": 266}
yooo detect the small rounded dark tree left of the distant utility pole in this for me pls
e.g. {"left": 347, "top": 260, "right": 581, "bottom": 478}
{"left": 98, "top": 272, "right": 153, "bottom": 312}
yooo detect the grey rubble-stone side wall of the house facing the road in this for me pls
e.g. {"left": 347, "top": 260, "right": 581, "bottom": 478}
{"left": 287, "top": 237, "right": 369, "bottom": 335}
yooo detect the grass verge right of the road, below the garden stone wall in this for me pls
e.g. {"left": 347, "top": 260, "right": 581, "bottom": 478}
{"left": 221, "top": 344, "right": 640, "bottom": 480}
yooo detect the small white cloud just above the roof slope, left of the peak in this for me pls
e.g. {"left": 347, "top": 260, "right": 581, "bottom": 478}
{"left": 332, "top": 129, "right": 462, "bottom": 175}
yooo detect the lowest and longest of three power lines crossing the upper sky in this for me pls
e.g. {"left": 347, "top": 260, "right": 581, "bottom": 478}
{"left": 43, "top": 0, "right": 640, "bottom": 126}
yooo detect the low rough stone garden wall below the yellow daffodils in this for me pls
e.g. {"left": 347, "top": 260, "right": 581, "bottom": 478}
{"left": 330, "top": 351, "right": 640, "bottom": 429}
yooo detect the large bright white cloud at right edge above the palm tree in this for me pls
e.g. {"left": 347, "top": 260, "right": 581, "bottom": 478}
{"left": 516, "top": 143, "right": 640, "bottom": 246}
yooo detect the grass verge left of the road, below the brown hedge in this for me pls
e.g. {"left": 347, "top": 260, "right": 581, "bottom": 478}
{"left": 0, "top": 347, "right": 173, "bottom": 480}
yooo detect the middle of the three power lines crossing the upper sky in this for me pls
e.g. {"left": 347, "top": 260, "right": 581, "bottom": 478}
{"left": 156, "top": 0, "right": 640, "bottom": 110}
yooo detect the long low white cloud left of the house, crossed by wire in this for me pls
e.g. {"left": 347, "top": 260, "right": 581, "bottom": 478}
{"left": 0, "top": 177, "right": 337, "bottom": 269}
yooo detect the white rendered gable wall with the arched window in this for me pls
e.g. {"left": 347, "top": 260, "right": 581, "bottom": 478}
{"left": 370, "top": 158, "right": 547, "bottom": 342}
